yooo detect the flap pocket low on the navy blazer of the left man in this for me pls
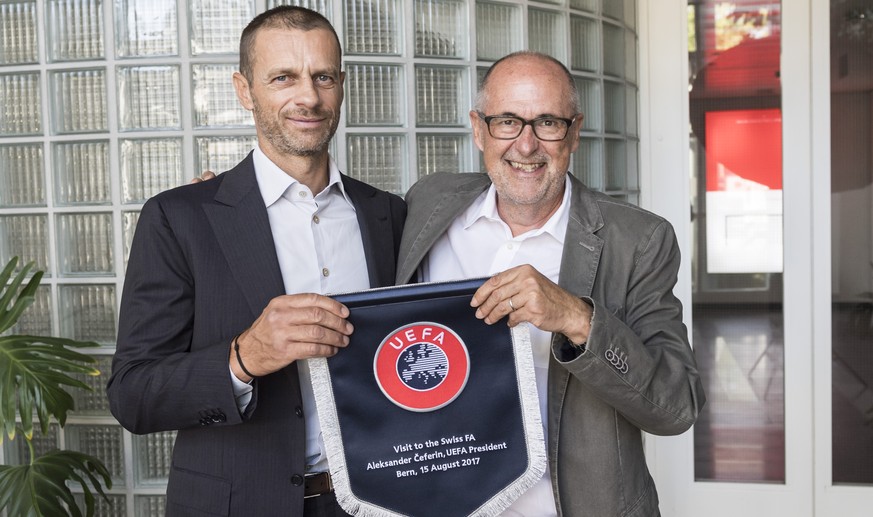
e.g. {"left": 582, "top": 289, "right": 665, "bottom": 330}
{"left": 167, "top": 467, "right": 231, "bottom": 516}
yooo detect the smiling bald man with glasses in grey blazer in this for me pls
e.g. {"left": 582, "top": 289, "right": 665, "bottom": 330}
{"left": 397, "top": 52, "right": 704, "bottom": 516}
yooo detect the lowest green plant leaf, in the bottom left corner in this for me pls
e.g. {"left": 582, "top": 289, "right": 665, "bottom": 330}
{"left": 0, "top": 450, "right": 112, "bottom": 517}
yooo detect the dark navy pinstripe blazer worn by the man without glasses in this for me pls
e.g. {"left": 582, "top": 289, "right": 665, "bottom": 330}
{"left": 107, "top": 151, "right": 406, "bottom": 516}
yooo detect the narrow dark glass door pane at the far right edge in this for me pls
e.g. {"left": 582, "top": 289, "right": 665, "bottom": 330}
{"left": 830, "top": 1, "right": 873, "bottom": 486}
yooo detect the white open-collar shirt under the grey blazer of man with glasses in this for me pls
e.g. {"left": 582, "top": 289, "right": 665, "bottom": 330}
{"left": 419, "top": 175, "right": 572, "bottom": 517}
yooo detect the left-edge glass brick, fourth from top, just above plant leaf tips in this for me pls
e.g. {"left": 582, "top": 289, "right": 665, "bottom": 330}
{"left": 0, "top": 214, "right": 52, "bottom": 276}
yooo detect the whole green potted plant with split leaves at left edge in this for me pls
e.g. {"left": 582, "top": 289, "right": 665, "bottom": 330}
{"left": 0, "top": 257, "right": 112, "bottom": 516}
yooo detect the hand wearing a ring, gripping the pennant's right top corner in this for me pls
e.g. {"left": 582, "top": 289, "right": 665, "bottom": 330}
{"left": 470, "top": 264, "right": 593, "bottom": 344}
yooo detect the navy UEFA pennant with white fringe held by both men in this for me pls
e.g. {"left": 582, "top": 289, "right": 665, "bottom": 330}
{"left": 309, "top": 279, "right": 546, "bottom": 517}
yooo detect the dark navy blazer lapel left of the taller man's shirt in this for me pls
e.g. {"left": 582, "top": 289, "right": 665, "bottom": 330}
{"left": 203, "top": 154, "right": 285, "bottom": 316}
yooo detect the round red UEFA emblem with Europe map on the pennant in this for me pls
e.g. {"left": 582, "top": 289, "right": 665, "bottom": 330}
{"left": 373, "top": 322, "right": 470, "bottom": 412}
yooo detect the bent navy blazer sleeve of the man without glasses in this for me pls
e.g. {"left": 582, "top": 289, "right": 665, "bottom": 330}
{"left": 107, "top": 196, "right": 250, "bottom": 434}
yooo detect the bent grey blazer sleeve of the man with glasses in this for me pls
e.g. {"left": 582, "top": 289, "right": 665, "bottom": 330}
{"left": 553, "top": 220, "right": 706, "bottom": 435}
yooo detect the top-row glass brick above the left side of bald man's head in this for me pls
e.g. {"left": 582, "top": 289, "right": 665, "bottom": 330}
{"left": 476, "top": 2, "right": 523, "bottom": 61}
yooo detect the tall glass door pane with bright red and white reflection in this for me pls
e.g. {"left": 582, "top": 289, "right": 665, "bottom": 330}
{"left": 688, "top": 0, "right": 785, "bottom": 483}
